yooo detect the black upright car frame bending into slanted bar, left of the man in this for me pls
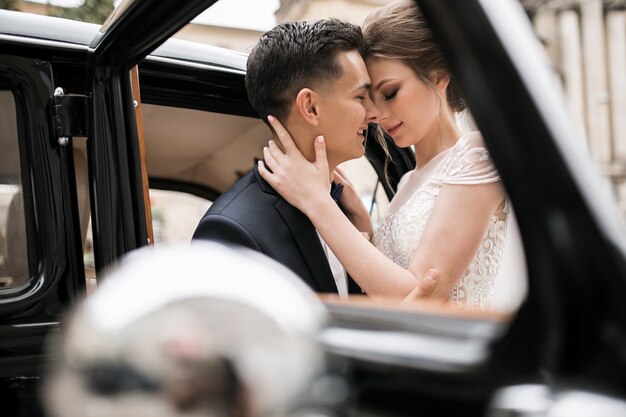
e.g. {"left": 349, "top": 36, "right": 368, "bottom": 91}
{"left": 88, "top": 0, "right": 222, "bottom": 271}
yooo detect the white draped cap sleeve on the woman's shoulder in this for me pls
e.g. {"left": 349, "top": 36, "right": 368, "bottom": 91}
{"left": 442, "top": 132, "right": 500, "bottom": 185}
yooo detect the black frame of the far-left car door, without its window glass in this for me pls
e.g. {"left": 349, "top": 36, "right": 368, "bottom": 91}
{"left": 0, "top": 42, "right": 85, "bottom": 414}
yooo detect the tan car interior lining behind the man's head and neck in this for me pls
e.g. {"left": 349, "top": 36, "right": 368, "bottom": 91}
{"left": 142, "top": 104, "right": 271, "bottom": 195}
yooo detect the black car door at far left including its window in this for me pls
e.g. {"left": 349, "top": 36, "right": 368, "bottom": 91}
{"left": 0, "top": 25, "right": 86, "bottom": 414}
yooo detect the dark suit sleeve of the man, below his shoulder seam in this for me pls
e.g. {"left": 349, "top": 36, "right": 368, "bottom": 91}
{"left": 192, "top": 214, "right": 261, "bottom": 252}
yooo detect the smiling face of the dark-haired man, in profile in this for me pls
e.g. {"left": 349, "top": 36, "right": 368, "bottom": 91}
{"left": 319, "top": 51, "right": 378, "bottom": 167}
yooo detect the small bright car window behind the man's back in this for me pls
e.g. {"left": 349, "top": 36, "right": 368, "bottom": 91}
{"left": 150, "top": 189, "right": 212, "bottom": 245}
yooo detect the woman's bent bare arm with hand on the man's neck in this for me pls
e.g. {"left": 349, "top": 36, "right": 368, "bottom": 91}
{"left": 259, "top": 118, "right": 501, "bottom": 299}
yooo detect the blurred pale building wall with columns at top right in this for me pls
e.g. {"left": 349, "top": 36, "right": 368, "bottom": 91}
{"left": 523, "top": 0, "right": 626, "bottom": 214}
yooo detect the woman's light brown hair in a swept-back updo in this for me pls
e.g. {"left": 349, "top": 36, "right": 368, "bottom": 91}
{"left": 361, "top": 0, "right": 466, "bottom": 112}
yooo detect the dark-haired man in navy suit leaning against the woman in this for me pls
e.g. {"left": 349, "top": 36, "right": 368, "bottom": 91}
{"left": 193, "top": 19, "right": 432, "bottom": 296}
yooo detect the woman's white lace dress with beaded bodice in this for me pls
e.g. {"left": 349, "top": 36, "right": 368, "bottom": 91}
{"left": 373, "top": 132, "right": 525, "bottom": 310}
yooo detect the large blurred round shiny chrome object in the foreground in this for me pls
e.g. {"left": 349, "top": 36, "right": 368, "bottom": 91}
{"left": 44, "top": 242, "right": 325, "bottom": 417}
